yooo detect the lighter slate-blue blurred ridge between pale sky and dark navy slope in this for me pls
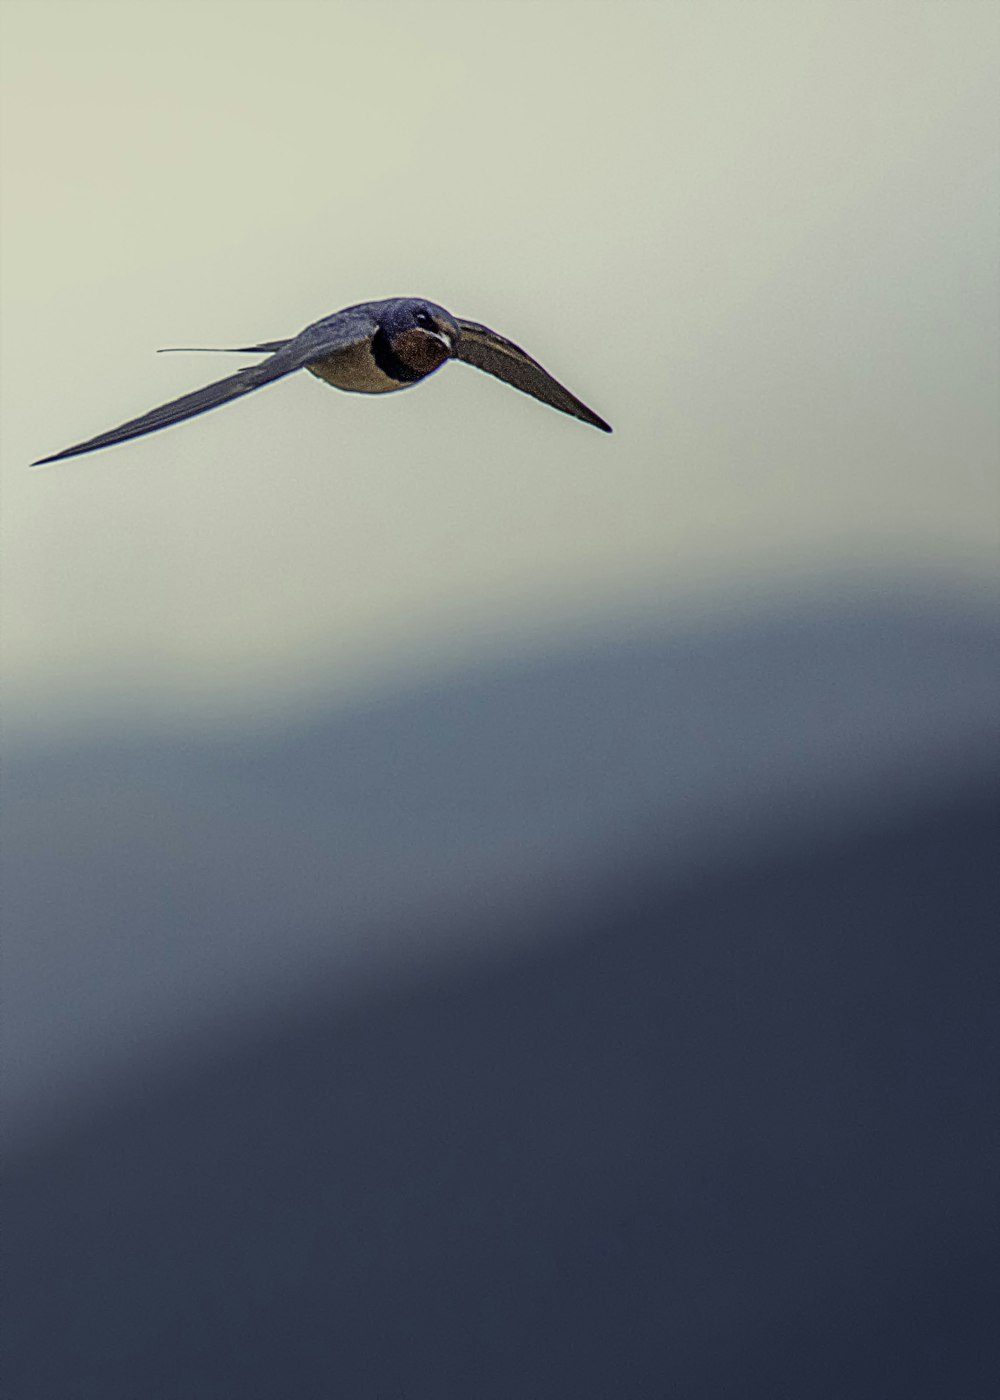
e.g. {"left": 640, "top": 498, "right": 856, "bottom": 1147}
{"left": 3, "top": 588, "right": 1000, "bottom": 1137}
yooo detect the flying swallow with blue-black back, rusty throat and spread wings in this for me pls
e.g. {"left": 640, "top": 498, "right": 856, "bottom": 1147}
{"left": 31, "top": 297, "right": 612, "bottom": 466}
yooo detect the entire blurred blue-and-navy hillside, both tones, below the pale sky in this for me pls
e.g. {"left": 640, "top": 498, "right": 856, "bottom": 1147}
{"left": 3, "top": 585, "right": 1000, "bottom": 1400}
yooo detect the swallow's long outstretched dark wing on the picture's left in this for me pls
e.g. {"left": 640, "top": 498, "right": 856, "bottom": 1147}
{"left": 32, "top": 308, "right": 377, "bottom": 466}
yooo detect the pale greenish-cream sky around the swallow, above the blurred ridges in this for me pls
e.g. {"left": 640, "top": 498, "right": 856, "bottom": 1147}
{"left": 0, "top": 0, "right": 1000, "bottom": 725}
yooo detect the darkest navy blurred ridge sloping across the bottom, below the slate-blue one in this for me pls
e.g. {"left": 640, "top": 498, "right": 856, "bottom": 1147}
{"left": 3, "top": 783, "right": 1000, "bottom": 1400}
